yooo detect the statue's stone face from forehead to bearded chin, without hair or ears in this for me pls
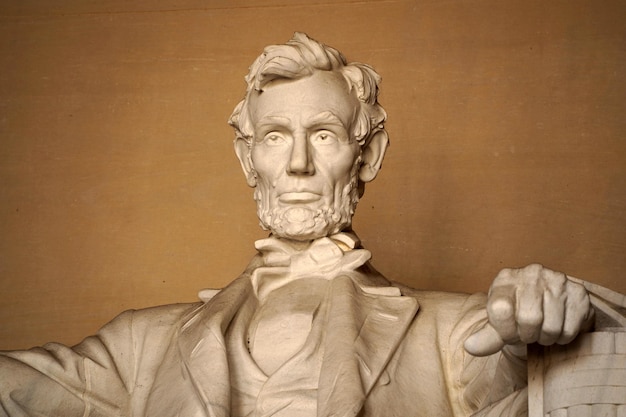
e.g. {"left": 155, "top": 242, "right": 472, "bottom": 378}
{"left": 249, "top": 71, "right": 361, "bottom": 240}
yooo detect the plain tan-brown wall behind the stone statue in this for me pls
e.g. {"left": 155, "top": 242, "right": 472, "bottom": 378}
{"left": 0, "top": 0, "right": 626, "bottom": 348}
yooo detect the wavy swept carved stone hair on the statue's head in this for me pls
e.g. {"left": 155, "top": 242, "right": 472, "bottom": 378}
{"left": 228, "top": 32, "right": 387, "bottom": 146}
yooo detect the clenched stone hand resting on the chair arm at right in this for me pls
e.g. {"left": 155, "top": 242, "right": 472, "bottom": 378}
{"left": 465, "top": 264, "right": 593, "bottom": 356}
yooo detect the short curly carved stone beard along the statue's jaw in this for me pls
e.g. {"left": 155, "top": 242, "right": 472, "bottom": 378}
{"left": 255, "top": 162, "right": 360, "bottom": 241}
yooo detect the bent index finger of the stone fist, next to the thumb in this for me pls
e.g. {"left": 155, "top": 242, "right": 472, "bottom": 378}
{"left": 487, "top": 283, "right": 519, "bottom": 343}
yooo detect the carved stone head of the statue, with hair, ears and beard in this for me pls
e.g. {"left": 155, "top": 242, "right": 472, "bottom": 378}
{"left": 229, "top": 33, "right": 388, "bottom": 241}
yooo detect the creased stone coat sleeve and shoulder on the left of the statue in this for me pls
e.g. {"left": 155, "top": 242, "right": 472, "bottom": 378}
{"left": 0, "top": 305, "right": 189, "bottom": 417}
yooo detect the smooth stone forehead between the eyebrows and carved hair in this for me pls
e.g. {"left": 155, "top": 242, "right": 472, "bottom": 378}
{"left": 249, "top": 71, "right": 360, "bottom": 128}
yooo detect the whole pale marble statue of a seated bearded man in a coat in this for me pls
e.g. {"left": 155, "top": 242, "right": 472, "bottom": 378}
{"left": 0, "top": 33, "right": 623, "bottom": 417}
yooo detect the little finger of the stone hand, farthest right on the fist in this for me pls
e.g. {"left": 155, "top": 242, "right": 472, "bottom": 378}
{"left": 557, "top": 281, "right": 593, "bottom": 344}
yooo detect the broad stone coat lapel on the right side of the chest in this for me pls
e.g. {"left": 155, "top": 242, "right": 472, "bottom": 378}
{"left": 318, "top": 275, "right": 419, "bottom": 417}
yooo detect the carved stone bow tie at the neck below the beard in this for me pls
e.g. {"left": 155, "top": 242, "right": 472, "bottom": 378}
{"left": 250, "top": 233, "right": 372, "bottom": 302}
